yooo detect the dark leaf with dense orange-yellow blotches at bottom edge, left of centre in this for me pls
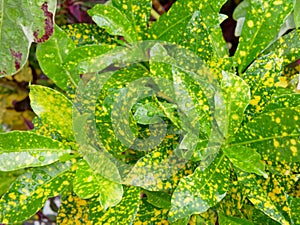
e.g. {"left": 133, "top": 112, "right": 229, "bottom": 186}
{"left": 56, "top": 192, "right": 92, "bottom": 225}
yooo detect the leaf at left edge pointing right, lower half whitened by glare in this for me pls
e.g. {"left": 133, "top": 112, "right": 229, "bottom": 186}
{"left": 0, "top": 131, "right": 70, "bottom": 171}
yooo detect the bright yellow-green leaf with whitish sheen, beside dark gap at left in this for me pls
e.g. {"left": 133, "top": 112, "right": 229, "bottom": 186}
{"left": 29, "top": 85, "right": 74, "bottom": 141}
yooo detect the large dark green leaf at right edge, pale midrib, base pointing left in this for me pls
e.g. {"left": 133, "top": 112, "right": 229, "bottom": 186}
{"left": 231, "top": 108, "right": 300, "bottom": 163}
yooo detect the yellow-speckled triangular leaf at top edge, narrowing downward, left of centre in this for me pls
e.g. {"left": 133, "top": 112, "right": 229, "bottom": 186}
{"left": 112, "top": 0, "right": 152, "bottom": 41}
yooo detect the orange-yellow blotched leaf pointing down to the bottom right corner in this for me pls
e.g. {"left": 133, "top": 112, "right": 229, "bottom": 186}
{"left": 238, "top": 173, "right": 290, "bottom": 224}
